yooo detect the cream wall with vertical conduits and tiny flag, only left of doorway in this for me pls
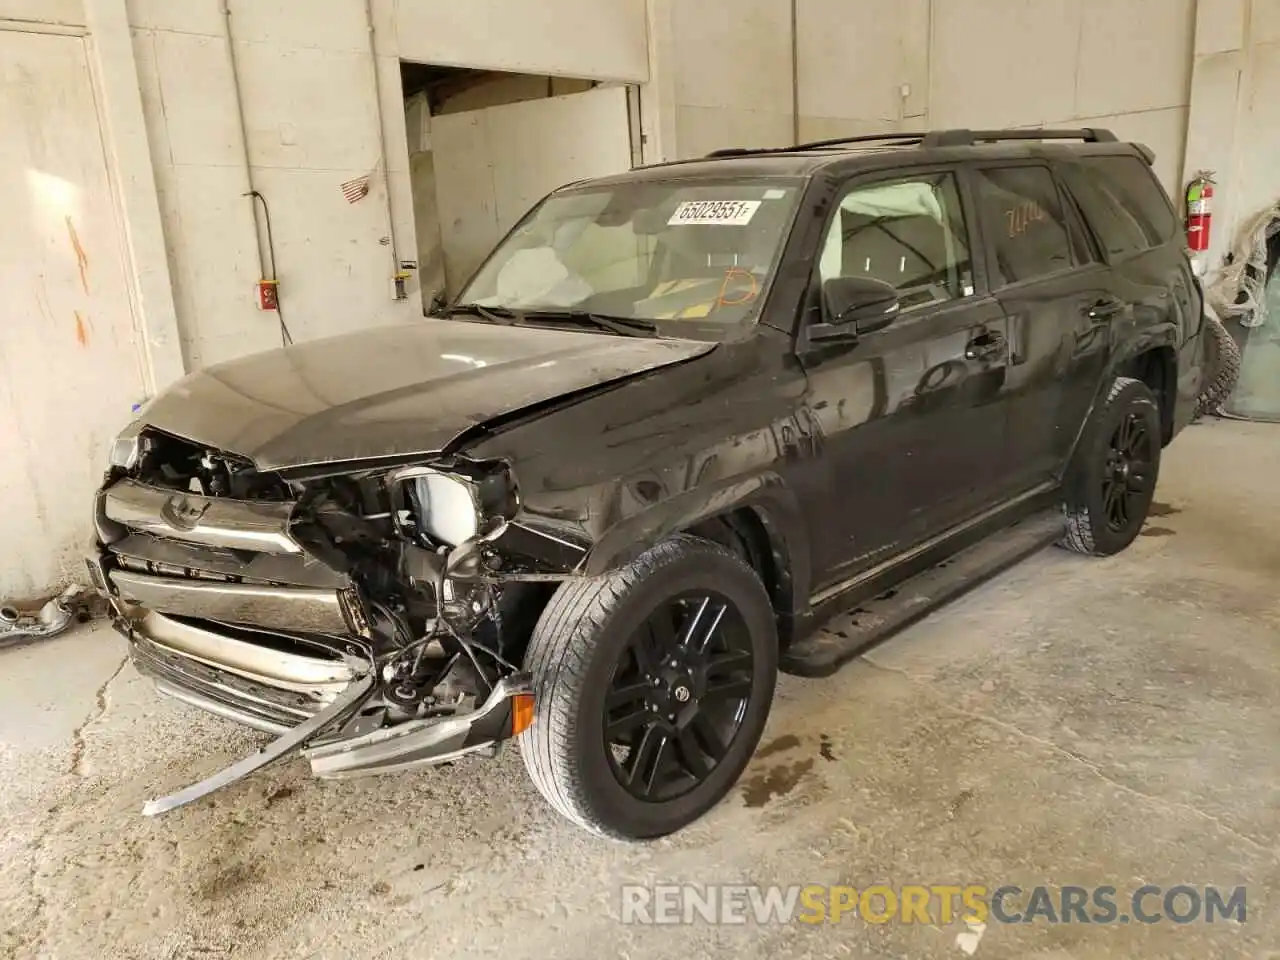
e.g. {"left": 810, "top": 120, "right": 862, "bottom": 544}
{"left": 129, "top": 0, "right": 416, "bottom": 367}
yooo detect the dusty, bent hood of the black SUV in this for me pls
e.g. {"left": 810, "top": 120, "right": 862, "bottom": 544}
{"left": 138, "top": 320, "right": 716, "bottom": 470}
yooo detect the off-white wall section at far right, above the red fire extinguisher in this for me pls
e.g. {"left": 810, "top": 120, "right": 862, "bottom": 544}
{"left": 1185, "top": 0, "right": 1280, "bottom": 268}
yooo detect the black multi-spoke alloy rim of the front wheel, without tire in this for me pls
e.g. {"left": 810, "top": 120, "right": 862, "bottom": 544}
{"left": 604, "top": 591, "right": 753, "bottom": 801}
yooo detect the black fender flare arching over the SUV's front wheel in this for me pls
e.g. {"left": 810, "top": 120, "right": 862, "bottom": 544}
{"left": 580, "top": 471, "right": 812, "bottom": 614}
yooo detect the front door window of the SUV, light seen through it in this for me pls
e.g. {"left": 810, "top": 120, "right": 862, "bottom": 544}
{"left": 818, "top": 173, "right": 973, "bottom": 310}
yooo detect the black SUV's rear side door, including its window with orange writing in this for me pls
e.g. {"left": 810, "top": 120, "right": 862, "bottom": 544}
{"left": 972, "top": 161, "right": 1129, "bottom": 494}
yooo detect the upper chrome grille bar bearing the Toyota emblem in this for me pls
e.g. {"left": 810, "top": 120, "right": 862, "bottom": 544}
{"left": 102, "top": 480, "right": 302, "bottom": 553}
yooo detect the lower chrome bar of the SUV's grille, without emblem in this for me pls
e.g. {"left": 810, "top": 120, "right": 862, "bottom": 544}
{"left": 106, "top": 570, "right": 357, "bottom": 634}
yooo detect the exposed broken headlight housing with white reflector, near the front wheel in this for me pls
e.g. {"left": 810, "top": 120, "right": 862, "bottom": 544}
{"left": 387, "top": 463, "right": 517, "bottom": 547}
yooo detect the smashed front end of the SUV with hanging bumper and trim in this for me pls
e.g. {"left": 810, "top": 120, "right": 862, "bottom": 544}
{"left": 90, "top": 430, "right": 573, "bottom": 814}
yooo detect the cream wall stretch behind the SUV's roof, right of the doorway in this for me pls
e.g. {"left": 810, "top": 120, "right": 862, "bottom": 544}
{"left": 646, "top": 0, "right": 1198, "bottom": 188}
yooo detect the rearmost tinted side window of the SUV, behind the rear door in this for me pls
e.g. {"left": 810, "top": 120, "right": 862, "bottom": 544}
{"left": 1066, "top": 156, "right": 1178, "bottom": 259}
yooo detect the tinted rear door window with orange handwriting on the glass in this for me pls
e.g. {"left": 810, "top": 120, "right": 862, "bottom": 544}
{"left": 978, "top": 166, "right": 1075, "bottom": 285}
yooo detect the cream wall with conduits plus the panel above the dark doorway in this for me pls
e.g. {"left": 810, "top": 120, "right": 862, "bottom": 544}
{"left": 128, "top": 0, "right": 648, "bottom": 367}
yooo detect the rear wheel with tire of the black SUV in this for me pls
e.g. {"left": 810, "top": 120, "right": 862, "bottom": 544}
{"left": 1059, "top": 376, "right": 1162, "bottom": 557}
